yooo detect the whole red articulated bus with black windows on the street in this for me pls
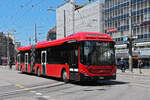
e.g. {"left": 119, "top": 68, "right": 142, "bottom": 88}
{"left": 16, "top": 32, "right": 116, "bottom": 82}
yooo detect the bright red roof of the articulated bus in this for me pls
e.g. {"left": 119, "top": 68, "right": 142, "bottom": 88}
{"left": 17, "top": 32, "right": 113, "bottom": 51}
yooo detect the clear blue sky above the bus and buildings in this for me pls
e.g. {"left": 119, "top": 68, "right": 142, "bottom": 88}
{"left": 0, "top": 0, "right": 93, "bottom": 46}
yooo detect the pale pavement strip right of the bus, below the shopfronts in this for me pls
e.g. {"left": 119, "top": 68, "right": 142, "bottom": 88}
{"left": 117, "top": 68, "right": 150, "bottom": 76}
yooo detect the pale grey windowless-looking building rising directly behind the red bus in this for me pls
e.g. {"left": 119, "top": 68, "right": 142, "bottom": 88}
{"left": 56, "top": 0, "right": 104, "bottom": 39}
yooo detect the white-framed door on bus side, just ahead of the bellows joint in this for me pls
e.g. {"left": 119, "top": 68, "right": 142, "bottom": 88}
{"left": 41, "top": 51, "right": 47, "bottom": 75}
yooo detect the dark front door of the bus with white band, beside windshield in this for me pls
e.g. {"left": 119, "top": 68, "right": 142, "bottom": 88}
{"left": 69, "top": 46, "right": 79, "bottom": 81}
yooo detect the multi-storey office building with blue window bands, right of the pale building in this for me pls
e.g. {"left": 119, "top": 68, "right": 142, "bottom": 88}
{"left": 104, "top": 0, "right": 150, "bottom": 67}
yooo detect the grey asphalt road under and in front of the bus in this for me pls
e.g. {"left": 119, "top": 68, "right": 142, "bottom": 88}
{"left": 0, "top": 68, "right": 150, "bottom": 100}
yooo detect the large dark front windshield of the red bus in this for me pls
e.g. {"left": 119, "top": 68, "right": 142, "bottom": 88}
{"left": 80, "top": 41, "right": 115, "bottom": 65}
